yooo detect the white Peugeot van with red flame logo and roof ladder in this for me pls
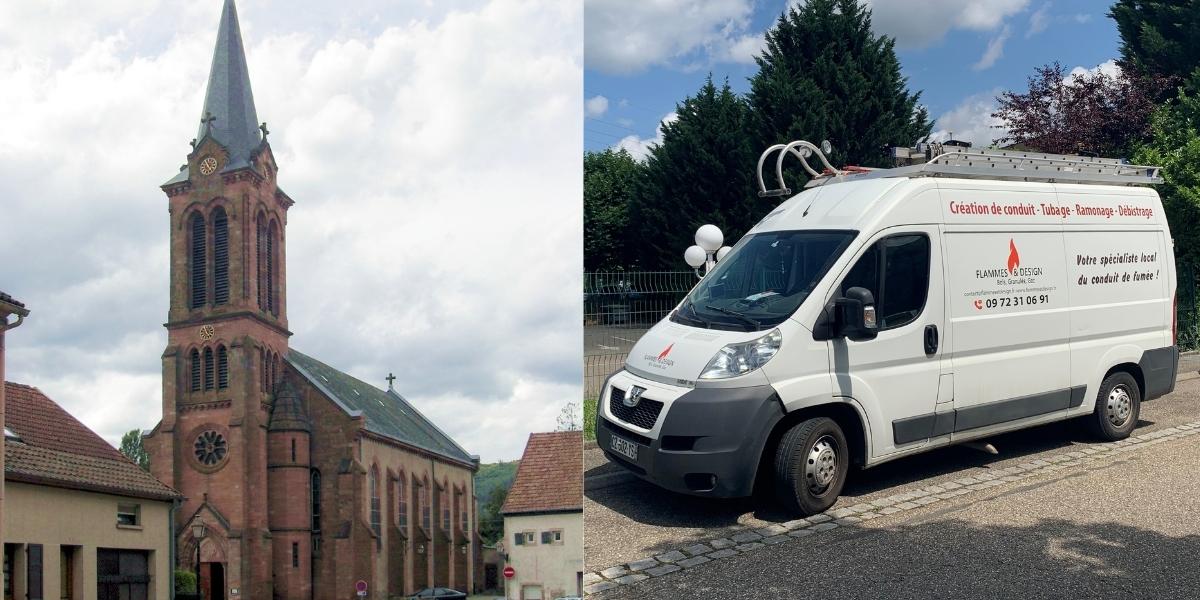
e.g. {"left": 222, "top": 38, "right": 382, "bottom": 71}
{"left": 596, "top": 142, "right": 1178, "bottom": 515}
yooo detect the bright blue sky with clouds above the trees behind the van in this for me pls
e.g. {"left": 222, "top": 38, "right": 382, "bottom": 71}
{"left": 583, "top": 0, "right": 1120, "bottom": 156}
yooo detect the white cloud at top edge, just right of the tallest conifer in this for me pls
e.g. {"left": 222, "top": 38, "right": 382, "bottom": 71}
{"left": 866, "top": 0, "right": 1030, "bottom": 48}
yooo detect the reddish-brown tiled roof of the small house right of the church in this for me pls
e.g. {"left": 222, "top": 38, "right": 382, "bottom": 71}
{"left": 500, "top": 431, "right": 583, "bottom": 516}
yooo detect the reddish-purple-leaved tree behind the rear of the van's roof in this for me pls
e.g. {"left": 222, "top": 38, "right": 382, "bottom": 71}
{"left": 992, "top": 62, "right": 1154, "bottom": 156}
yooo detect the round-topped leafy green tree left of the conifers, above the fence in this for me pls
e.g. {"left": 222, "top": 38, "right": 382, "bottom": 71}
{"left": 583, "top": 149, "right": 642, "bottom": 271}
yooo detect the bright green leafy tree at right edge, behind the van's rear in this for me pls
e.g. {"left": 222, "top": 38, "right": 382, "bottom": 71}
{"left": 1133, "top": 76, "right": 1200, "bottom": 272}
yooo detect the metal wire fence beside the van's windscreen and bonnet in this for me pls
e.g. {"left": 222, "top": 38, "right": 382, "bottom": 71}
{"left": 583, "top": 271, "right": 698, "bottom": 398}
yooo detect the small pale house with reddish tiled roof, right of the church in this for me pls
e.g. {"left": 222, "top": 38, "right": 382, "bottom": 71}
{"left": 500, "top": 431, "right": 583, "bottom": 600}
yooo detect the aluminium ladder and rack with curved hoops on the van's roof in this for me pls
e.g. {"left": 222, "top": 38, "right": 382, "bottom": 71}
{"left": 758, "top": 140, "right": 1163, "bottom": 197}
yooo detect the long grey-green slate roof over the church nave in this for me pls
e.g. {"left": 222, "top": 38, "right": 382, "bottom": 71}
{"left": 287, "top": 349, "right": 475, "bottom": 464}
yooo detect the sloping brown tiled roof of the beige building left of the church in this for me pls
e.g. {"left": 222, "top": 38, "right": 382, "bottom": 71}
{"left": 4, "top": 382, "right": 179, "bottom": 499}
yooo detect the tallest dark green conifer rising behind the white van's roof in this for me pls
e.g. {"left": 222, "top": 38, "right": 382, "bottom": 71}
{"left": 748, "top": 0, "right": 931, "bottom": 180}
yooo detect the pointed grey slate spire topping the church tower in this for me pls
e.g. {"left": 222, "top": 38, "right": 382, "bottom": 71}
{"left": 196, "top": 0, "right": 263, "bottom": 170}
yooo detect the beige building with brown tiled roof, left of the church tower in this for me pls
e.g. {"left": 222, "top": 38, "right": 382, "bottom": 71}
{"left": 4, "top": 382, "right": 179, "bottom": 600}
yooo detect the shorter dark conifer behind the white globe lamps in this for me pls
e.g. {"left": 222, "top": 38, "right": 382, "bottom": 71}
{"left": 624, "top": 76, "right": 772, "bottom": 270}
